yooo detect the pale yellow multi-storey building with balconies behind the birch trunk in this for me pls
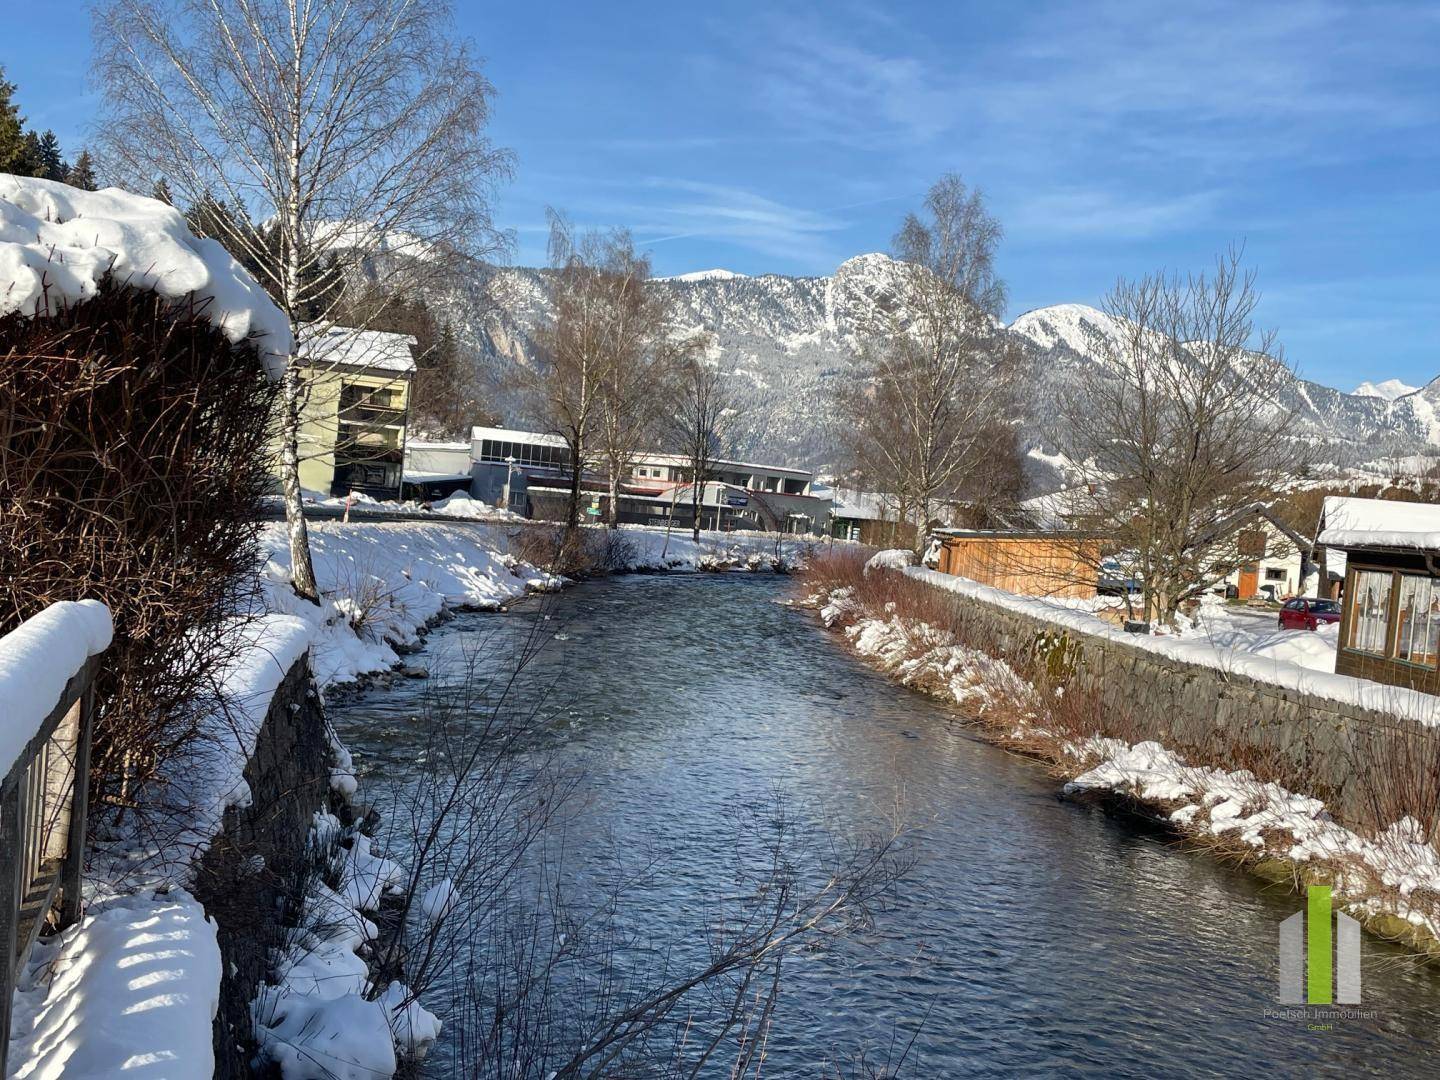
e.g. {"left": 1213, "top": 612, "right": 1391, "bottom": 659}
{"left": 279, "top": 324, "right": 415, "bottom": 498}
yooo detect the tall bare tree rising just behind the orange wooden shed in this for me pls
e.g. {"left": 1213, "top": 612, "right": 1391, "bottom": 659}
{"left": 840, "top": 174, "right": 1018, "bottom": 547}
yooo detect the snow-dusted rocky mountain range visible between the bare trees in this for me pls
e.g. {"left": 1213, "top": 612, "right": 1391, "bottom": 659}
{"left": 420, "top": 255, "right": 1440, "bottom": 481}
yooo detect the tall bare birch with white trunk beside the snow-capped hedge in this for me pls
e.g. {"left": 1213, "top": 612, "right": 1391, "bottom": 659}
{"left": 95, "top": 0, "right": 510, "bottom": 599}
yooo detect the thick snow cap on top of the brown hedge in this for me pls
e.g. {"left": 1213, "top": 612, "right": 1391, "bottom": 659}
{"left": 0, "top": 173, "right": 291, "bottom": 377}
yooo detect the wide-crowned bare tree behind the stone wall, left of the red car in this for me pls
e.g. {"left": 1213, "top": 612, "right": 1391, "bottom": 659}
{"left": 1064, "top": 248, "right": 1306, "bottom": 624}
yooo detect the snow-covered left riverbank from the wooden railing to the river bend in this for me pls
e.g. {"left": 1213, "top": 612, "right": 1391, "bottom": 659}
{"left": 9, "top": 516, "right": 812, "bottom": 1080}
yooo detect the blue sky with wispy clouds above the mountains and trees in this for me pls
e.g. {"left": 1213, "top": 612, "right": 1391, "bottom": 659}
{"left": 8, "top": 0, "right": 1440, "bottom": 389}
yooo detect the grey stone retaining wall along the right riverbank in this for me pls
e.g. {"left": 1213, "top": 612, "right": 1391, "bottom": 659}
{"left": 927, "top": 576, "right": 1440, "bottom": 827}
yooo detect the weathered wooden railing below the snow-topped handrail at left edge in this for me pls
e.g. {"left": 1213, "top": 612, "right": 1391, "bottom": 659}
{"left": 0, "top": 655, "right": 99, "bottom": 1077}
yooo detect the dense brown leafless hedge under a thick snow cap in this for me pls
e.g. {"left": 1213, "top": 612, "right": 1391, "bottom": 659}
{"left": 0, "top": 279, "right": 275, "bottom": 801}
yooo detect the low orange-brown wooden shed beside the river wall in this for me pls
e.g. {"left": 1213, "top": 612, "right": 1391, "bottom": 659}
{"left": 935, "top": 528, "right": 1100, "bottom": 599}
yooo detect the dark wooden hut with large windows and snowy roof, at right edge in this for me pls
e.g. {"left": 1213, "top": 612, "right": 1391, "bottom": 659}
{"left": 1320, "top": 495, "right": 1440, "bottom": 694}
